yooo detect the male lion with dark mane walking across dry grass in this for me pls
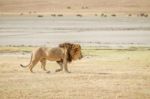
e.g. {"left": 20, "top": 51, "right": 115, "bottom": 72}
{"left": 20, "top": 43, "right": 83, "bottom": 73}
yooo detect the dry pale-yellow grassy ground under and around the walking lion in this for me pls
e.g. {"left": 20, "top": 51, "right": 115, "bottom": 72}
{"left": 0, "top": 47, "right": 150, "bottom": 99}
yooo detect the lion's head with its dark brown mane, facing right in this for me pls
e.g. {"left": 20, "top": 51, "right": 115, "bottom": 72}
{"left": 59, "top": 43, "right": 83, "bottom": 62}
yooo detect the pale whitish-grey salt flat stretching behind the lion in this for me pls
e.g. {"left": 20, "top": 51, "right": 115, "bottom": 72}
{"left": 0, "top": 16, "right": 150, "bottom": 46}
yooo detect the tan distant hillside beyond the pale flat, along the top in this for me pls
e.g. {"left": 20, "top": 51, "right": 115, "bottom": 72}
{"left": 0, "top": 0, "right": 150, "bottom": 14}
